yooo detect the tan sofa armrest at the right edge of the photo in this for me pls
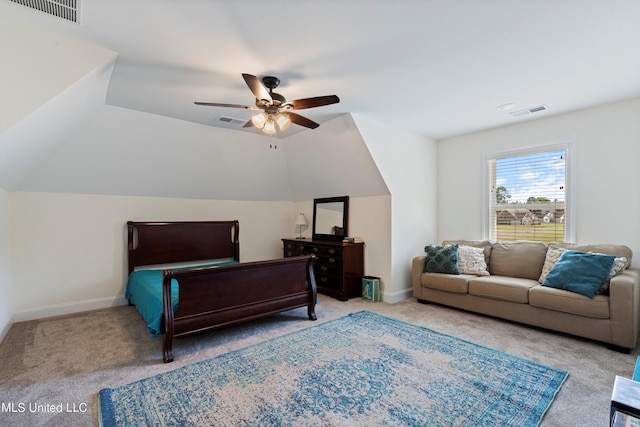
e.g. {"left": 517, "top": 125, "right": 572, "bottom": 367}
{"left": 609, "top": 268, "right": 640, "bottom": 348}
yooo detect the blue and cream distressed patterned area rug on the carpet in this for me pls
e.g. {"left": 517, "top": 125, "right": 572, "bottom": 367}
{"left": 98, "top": 311, "right": 567, "bottom": 427}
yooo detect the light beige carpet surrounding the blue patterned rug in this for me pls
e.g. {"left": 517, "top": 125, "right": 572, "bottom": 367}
{"left": 0, "top": 295, "right": 638, "bottom": 427}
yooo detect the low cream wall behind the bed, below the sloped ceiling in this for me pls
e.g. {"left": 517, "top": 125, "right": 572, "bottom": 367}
{"left": 10, "top": 192, "right": 294, "bottom": 321}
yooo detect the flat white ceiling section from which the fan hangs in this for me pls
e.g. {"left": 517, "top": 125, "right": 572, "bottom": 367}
{"left": 1, "top": 0, "right": 640, "bottom": 138}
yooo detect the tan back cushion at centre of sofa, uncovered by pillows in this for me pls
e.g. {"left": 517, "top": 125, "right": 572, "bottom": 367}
{"left": 489, "top": 242, "right": 547, "bottom": 281}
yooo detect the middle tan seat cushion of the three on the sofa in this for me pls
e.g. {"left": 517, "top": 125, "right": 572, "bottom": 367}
{"left": 469, "top": 276, "right": 539, "bottom": 304}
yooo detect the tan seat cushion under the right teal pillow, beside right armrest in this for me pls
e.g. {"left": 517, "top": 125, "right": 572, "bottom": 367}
{"left": 529, "top": 285, "right": 610, "bottom": 319}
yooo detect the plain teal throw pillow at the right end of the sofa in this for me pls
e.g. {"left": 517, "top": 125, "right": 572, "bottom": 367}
{"left": 542, "top": 250, "right": 616, "bottom": 298}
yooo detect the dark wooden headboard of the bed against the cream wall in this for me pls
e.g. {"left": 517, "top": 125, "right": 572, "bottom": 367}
{"left": 127, "top": 220, "right": 240, "bottom": 274}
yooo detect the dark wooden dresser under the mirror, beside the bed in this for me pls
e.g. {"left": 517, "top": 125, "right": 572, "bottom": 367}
{"left": 282, "top": 239, "right": 364, "bottom": 301}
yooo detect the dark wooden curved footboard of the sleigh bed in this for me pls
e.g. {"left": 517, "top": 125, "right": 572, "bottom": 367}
{"left": 162, "top": 255, "right": 317, "bottom": 362}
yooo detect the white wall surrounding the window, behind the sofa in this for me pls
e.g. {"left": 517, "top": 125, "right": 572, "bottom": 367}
{"left": 437, "top": 98, "right": 640, "bottom": 267}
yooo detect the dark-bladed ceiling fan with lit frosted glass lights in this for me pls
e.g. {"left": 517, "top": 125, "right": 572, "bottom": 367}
{"left": 194, "top": 74, "right": 340, "bottom": 134}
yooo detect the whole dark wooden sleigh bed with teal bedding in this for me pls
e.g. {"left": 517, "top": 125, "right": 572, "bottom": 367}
{"left": 126, "top": 221, "right": 317, "bottom": 362}
